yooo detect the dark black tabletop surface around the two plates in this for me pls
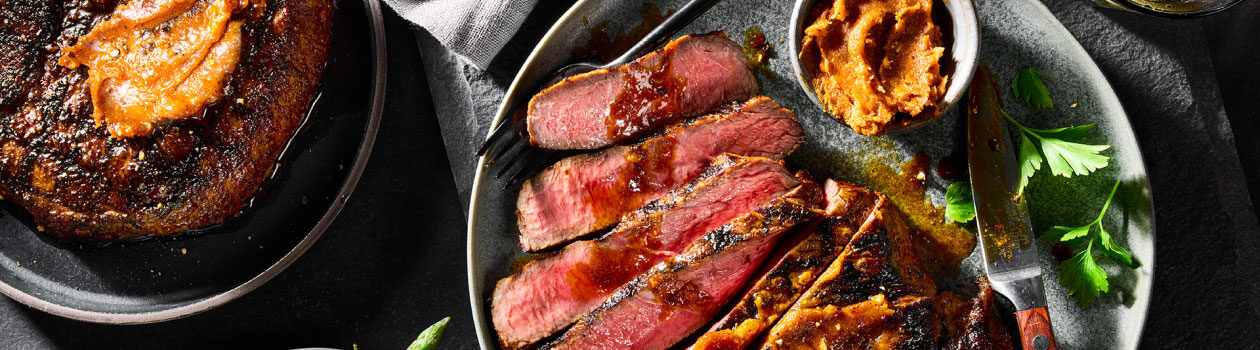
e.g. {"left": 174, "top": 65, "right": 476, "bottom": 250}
{"left": 0, "top": 0, "right": 1260, "bottom": 349}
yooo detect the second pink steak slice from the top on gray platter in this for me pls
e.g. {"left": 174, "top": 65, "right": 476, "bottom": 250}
{"left": 517, "top": 97, "right": 805, "bottom": 252}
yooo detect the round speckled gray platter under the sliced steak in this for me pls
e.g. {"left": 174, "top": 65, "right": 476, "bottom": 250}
{"left": 467, "top": 0, "right": 1155, "bottom": 349}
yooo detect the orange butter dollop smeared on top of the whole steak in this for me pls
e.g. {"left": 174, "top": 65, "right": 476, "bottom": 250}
{"left": 58, "top": 0, "right": 261, "bottom": 137}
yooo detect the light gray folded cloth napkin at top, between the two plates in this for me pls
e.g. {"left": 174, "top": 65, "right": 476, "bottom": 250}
{"left": 384, "top": 0, "right": 538, "bottom": 69}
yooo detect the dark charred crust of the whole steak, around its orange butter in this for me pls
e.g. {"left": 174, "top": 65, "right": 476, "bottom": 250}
{"left": 0, "top": 0, "right": 333, "bottom": 243}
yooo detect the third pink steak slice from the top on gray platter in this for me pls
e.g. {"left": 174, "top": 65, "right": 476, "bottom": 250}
{"left": 490, "top": 155, "right": 800, "bottom": 349}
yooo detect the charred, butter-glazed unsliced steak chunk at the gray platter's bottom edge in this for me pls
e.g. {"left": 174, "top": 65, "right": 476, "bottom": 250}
{"left": 761, "top": 196, "right": 940, "bottom": 349}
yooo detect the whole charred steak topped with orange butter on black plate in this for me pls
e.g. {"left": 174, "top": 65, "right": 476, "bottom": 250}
{"left": 0, "top": 0, "right": 333, "bottom": 243}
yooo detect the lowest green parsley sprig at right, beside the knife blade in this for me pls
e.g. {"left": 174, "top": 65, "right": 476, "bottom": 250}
{"left": 1041, "top": 180, "right": 1137, "bottom": 307}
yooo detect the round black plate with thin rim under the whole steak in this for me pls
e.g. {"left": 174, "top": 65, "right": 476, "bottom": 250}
{"left": 0, "top": 0, "right": 386, "bottom": 324}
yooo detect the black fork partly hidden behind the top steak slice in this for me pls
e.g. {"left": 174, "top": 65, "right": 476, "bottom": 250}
{"left": 476, "top": 0, "right": 721, "bottom": 186}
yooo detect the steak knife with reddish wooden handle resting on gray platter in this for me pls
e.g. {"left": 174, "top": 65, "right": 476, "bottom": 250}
{"left": 966, "top": 63, "right": 1058, "bottom": 350}
